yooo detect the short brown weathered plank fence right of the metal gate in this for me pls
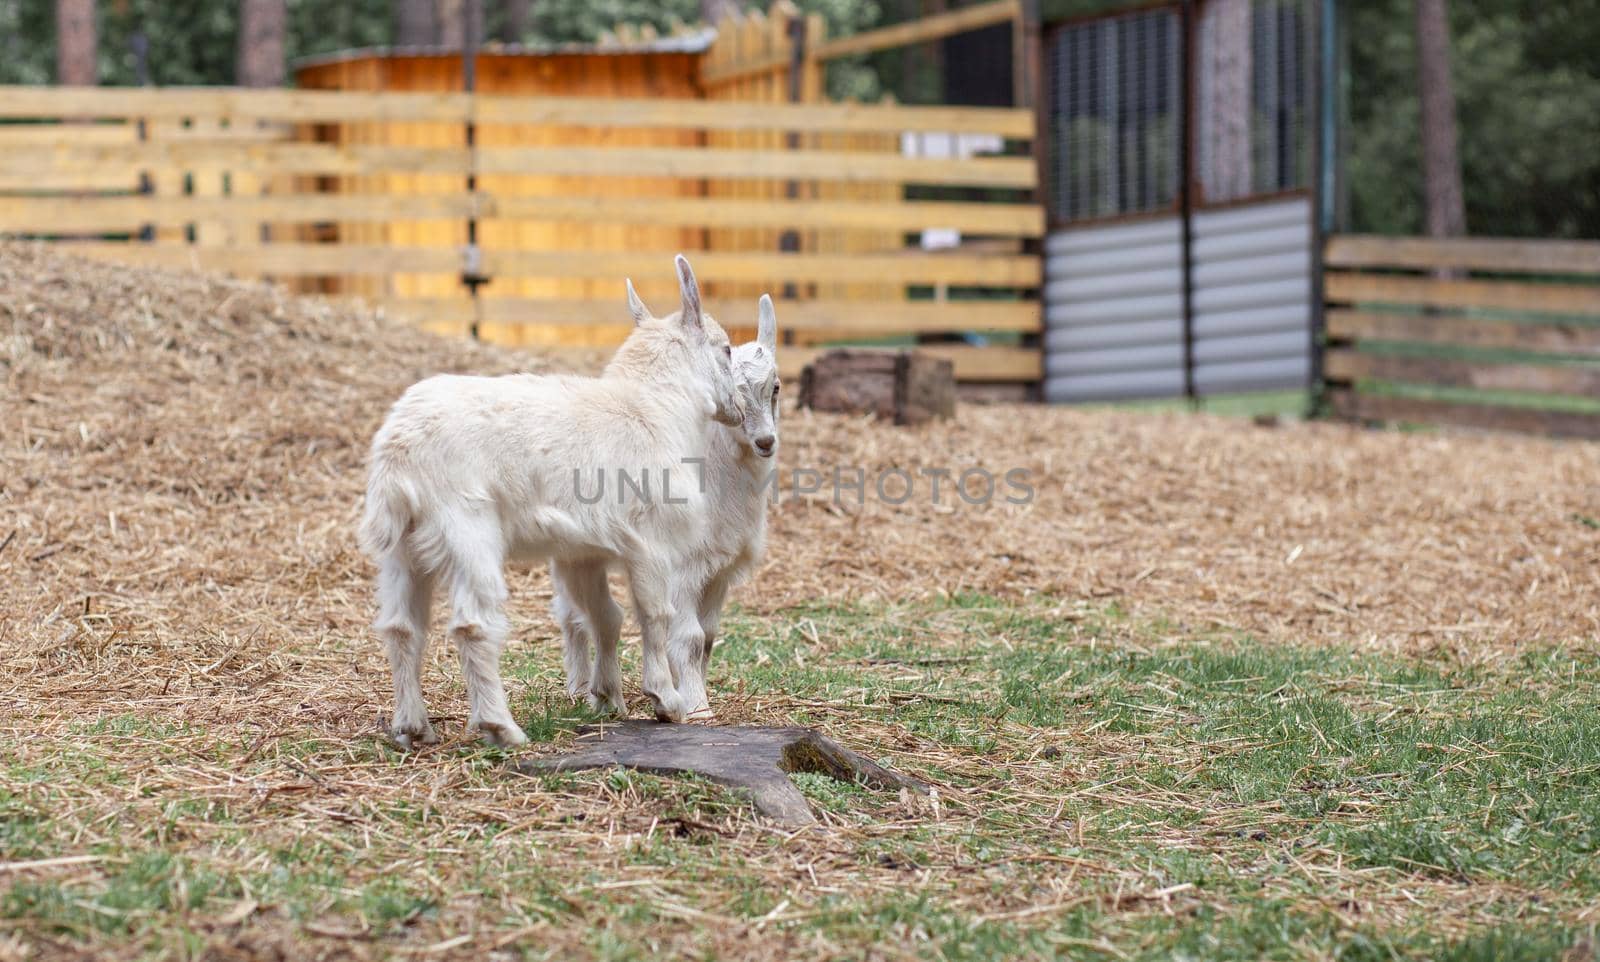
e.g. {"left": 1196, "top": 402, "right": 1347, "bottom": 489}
{"left": 1325, "top": 235, "right": 1600, "bottom": 439}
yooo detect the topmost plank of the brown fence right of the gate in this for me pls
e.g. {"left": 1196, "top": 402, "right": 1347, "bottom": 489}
{"left": 1326, "top": 234, "right": 1600, "bottom": 274}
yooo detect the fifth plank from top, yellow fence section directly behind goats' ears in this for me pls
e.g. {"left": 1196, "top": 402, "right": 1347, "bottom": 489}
{"left": 478, "top": 296, "right": 1040, "bottom": 338}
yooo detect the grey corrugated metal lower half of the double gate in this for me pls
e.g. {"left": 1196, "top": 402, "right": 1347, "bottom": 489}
{"left": 1043, "top": 197, "right": 1312, "bottom": 402}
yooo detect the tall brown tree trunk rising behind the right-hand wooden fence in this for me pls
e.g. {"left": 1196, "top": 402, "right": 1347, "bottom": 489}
{"left": 1416, "top": 0, "right": 1467, "bottom": 237}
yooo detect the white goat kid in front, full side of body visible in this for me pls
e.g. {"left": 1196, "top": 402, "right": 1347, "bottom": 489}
{"left": 360, "top": 255, "right": 739, "bottom": 748}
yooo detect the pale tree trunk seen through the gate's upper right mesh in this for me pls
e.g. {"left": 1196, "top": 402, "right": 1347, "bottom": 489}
{"left": 1198, "top": 0, "right": 1254, "bottom": 202}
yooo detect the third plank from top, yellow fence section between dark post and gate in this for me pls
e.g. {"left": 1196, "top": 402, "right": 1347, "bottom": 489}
{"left": 478, "top": 194, "right": 1045, "bottom": 237}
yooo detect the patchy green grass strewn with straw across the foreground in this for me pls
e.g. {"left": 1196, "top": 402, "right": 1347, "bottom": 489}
{"left": 0, "top": 595, "right": 1600, "bottom": 960}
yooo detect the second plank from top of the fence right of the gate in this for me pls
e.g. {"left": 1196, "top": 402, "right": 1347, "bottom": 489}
{"left": 1323, "top": 272, "right": 1600, "bottom": 315}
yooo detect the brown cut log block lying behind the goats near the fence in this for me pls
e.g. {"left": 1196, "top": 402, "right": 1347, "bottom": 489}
{"left": 800, "top": 351, "right": 955, "bottom": 424}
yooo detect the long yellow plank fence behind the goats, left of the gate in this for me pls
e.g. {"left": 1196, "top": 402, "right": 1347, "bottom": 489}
{"left": 0, "top": 81, "right": 1043, "bottom": 381}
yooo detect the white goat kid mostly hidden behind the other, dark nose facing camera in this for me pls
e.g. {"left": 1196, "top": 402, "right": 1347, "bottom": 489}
{"left": 550, "top": 295, "right": 778, "bottom": 717}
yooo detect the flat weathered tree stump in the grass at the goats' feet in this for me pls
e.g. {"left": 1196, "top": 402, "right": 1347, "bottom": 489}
{"left": 517, "top": 719, "right": 928, "bottom": 826}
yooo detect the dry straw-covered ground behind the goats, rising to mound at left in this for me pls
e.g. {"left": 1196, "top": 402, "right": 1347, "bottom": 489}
{"left": 0, "top": 245, "right": 1600, "bottom": 953}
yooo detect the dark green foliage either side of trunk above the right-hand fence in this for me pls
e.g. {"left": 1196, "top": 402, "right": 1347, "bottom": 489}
{"left": 1346, "top": 0, "right": 1600, "bottom": 237}
